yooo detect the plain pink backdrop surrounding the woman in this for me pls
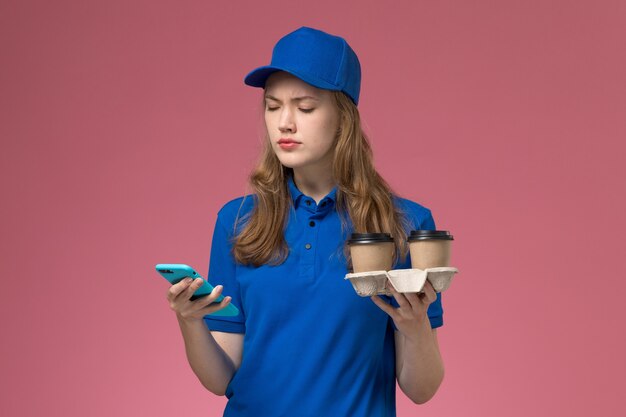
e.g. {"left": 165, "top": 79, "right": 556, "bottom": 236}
{"left": 0, "top": 0, "right": 626, "bottom": 417}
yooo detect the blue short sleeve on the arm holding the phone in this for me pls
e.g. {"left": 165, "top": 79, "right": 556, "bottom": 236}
{"left": 204, "top": 214, "right": 246, "bottom": 333}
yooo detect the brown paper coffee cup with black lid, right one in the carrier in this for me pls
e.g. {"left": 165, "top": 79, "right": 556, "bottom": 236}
{"left": 408, "top": 230, "right": 454, "bottom": 269}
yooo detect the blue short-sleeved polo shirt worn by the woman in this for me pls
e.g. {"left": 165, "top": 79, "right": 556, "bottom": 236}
{"left": 204, "top": 178, "right": 443, "bottom": 417}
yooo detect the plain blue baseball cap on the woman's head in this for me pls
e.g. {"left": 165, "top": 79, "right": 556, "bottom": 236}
{"left": 244, "top": 26, "right": 361, "bottom": 105}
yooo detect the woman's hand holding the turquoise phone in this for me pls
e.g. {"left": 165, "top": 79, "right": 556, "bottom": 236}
{"left": 167, "top": 277, "right": 232, "bottom": 321}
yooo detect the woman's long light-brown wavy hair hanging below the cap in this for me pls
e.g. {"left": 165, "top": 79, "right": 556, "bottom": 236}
{"left": 233, "top": 91, "right": 408, "bottom": 266}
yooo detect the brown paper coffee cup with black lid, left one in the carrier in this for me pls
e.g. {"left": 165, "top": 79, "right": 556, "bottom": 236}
{"left": 348, "top": 233, "right": 395, "bottom": 273}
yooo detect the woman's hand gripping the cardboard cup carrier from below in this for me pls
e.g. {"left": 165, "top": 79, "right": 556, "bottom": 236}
{"left": 370, "top": 280, "right": 437, "bottom": 339}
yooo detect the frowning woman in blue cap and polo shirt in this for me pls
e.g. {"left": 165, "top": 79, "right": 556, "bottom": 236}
{"left": 168, "top": 27, "right": 443, "bottom": 417}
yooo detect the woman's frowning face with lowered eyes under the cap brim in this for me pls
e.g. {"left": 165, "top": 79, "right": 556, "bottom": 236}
{"left": 264, "top": 71, "right": 339, "bottom": 169}
